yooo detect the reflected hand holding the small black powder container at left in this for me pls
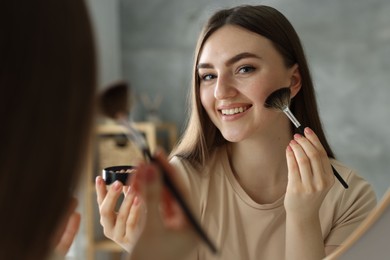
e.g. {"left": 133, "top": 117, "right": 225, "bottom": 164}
{"left": 95, "top": 176, "right": 145, "bottom": 252}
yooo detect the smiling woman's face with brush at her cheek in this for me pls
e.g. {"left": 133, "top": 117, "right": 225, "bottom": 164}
{"left": 197, "top": 25, "right": 297, "bottom": 142}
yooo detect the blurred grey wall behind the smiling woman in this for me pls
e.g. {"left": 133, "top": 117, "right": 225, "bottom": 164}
{"left": 89, "top": 0, "right": 390, "bottom": 203}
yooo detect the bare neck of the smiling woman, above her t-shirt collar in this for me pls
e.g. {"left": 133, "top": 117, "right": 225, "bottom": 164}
{"left": 228, "top": 125, "right": 292, "bottom": 203}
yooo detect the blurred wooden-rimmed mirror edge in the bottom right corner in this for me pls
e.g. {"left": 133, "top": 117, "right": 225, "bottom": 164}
{"left": 325, "top": 188, "right": 390, "bottom": 260}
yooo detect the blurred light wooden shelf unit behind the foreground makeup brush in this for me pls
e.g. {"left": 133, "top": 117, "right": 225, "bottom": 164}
{"left": 85, "top": 122, "right": 177, "bottom": 260}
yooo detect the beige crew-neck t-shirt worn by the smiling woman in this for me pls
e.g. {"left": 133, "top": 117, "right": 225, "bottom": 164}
{"left": 171, "top": 147, "right": 376, "bottom": 260}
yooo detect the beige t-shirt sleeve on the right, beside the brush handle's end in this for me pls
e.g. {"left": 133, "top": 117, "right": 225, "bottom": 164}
{"left": 325, "top": 171, "right": 376, "bottom": 246}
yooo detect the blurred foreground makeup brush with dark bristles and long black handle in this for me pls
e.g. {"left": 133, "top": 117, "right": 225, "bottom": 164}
{"left": 99, "top": 85, "right": 218, "bottom": 254}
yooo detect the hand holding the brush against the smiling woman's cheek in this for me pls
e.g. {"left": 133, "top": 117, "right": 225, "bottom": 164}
{"left": 284, "top": 128, "right": 335, "bottom": 219}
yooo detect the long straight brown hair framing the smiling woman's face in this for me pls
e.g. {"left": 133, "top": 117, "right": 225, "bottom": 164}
{"left": 171, "top": 5, "right": 334, "bottom": 166}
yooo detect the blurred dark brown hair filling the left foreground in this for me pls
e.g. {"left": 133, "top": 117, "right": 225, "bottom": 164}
{"left": 0, "top": 0, "right": 96, "bottom": 260}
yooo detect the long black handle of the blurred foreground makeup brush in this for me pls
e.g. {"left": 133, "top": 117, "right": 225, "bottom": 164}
{"left": 143, "top": 149, "right": 218, "bottom": 254}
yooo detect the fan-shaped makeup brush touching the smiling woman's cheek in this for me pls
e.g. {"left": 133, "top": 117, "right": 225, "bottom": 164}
{"left": 264, "top": 87, "right": 348, "bottom": 189}
